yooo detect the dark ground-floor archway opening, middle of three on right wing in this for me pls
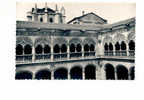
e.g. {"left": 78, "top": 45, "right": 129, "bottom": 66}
{"left": 116, "top": 65, "right": 128, "bottom": 80}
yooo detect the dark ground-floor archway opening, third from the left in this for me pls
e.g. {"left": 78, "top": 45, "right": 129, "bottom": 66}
{"left": 54, "top": 68, "right": 68, "bottom": 80}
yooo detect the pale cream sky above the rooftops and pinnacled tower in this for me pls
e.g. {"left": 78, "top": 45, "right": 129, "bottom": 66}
{"left": 16, "top": 2, "right": 136, "bottom": 23}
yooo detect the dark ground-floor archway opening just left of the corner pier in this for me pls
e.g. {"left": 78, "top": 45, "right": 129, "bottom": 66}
{"left": 85, "top": 65, "right": 96, "bottom": 79}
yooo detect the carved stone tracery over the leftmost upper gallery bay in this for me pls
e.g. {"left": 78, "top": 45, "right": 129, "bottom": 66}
{"left": 16, "top": 37, "right": 33, "bottom": 46}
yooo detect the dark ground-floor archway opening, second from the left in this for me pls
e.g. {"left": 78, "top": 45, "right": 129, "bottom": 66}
{"left": 35, "top": 70, "right": 51, "bottom": 80}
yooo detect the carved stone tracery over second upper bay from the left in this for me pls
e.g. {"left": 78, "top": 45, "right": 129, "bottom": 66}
{"left": 34, "top": 37, "right": 51, "bottom": 47}
